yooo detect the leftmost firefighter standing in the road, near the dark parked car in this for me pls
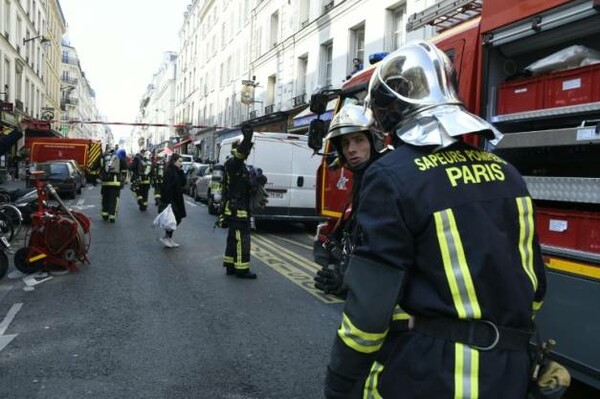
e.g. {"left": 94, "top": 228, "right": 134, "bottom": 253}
{"left": 100, "top": 145, "right": 127, "bottom": 223}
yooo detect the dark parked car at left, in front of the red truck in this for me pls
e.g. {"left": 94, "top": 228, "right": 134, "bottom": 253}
{"left": 30, "top": 161, "right": 82, "bottom": 198}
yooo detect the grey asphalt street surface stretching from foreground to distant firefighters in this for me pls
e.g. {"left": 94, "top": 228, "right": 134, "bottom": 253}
{"left": 0, "top": 188, "right": 341, "bottom": 399}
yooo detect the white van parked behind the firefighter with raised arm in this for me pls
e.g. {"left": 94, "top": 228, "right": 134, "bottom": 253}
{"left": 219, "top": 132, "right": 322, "bottom": 222}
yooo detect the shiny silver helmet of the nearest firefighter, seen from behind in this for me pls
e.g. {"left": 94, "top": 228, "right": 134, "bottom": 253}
{"left": 368, "top": 41, "right": 502, "bottom": 147}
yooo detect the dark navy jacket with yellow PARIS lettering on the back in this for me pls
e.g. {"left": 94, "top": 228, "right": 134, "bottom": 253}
{"left": 326, "top": 143, "right": 546, "bottom": 398}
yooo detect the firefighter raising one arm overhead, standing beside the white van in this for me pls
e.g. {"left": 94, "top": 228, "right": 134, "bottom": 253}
{"left": 219, "top": 124, "right": 256, "bottom": 279}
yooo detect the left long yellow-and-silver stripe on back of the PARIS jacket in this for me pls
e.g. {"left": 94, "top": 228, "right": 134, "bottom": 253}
{"left": 433, "top": 209, "right": 481, "bottom": 319}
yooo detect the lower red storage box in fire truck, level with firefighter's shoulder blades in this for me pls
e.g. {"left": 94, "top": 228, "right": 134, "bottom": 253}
{"left": 536, "top": 208, "right": 600, "bottom": 254}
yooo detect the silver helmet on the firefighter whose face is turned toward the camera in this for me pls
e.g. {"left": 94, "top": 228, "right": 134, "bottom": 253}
{"left": 325, "top": 104, "right": 386, "bottom": 162}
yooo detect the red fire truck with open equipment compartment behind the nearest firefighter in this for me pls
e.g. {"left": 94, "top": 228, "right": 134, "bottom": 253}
{"left": 315, "top": 0, "right": 600, "bottom": 388}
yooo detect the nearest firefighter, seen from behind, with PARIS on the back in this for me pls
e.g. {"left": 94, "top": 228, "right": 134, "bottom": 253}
{"left": 325, "top": 42, "right": 546, "bottom": 399}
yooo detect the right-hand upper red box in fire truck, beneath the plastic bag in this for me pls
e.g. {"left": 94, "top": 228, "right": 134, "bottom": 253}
{"left": 544, "top": 64, "right": 600, "bottom": 108}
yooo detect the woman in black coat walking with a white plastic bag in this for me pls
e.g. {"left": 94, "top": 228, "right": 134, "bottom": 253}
{"left": 158, "top": 154, "right": 186, "bottom": 248}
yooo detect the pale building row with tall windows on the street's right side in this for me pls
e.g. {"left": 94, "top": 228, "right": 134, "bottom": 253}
{"left": 175, "top": 0, "right": 435, "bottom": 158}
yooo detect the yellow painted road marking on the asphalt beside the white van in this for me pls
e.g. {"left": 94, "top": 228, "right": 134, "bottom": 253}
{"left": 252, "top": 235, "right": 342, "bottom": 303}
